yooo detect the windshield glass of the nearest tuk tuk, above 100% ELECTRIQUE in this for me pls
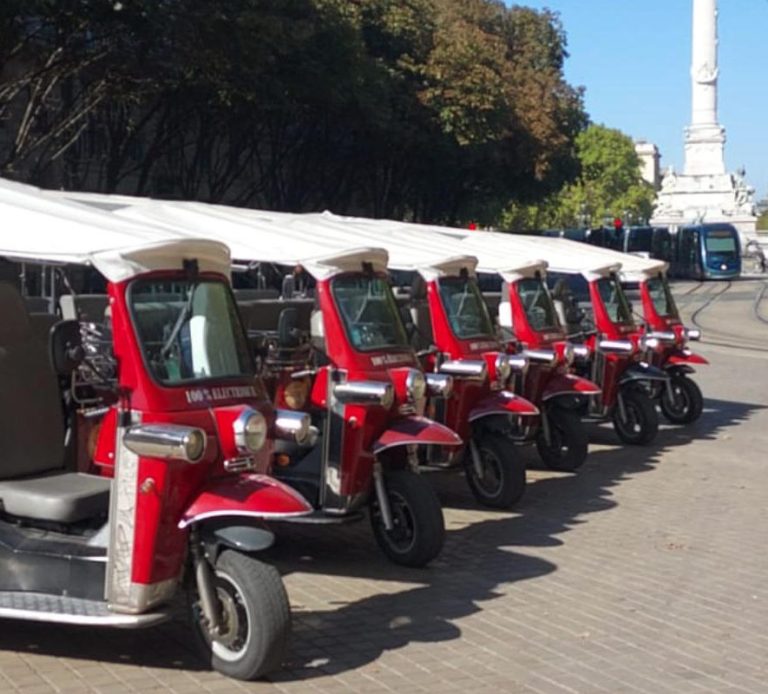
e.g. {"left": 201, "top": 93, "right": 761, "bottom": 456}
{"left": 128, "top": 279, "right": 254, "bottom": 386}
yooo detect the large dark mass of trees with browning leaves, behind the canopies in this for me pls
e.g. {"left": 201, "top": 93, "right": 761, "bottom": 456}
{"left": 0, "top": 0, "right": 586, "bottom": 223}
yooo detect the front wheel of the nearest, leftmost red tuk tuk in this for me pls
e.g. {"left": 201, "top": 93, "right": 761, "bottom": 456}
{"left": 190, "top": 550, "right": 291, "bottom": 680}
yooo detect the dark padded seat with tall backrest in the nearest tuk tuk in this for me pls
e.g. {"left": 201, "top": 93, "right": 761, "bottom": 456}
{"left": 0, "top": 282, "right": 110, "bottom": 524}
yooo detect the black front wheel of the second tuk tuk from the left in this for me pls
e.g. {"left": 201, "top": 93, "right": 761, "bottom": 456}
{"left": 370, "top": 470, "right": 445, "bottom": 567}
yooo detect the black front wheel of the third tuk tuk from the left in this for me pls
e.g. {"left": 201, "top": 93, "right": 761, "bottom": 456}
{"left": 464, "top": 433, "right": 526, "bottom": 508}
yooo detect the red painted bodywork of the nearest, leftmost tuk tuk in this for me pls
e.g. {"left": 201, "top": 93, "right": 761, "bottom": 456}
{"left": 94, "top": 273, "right": 311, "bottom": 586}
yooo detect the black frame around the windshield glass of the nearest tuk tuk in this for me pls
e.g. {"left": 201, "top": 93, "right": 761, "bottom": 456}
{"left": 125, "top": 273, "right": 257, "bottom": 389}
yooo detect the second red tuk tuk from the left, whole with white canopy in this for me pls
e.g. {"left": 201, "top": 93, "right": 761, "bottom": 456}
{"left": 104, "top": 203, "right": 462, "bottom": 566}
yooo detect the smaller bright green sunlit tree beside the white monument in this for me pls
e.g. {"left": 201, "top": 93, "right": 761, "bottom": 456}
{"left": 503, "top": 124, "right": 655, "bottom": 229}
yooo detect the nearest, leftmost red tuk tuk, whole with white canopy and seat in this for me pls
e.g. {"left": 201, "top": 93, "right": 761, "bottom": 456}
{"left": 0, "top": 182, "right": 311, "bottom": 679}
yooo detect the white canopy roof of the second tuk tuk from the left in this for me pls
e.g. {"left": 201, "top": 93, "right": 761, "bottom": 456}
{"left": 114, "top": 201, "right": 387, "bottom": 279}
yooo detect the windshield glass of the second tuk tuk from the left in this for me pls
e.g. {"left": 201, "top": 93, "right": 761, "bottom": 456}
{"left": 331, "top": 274, "right": 409, "bottom": 352}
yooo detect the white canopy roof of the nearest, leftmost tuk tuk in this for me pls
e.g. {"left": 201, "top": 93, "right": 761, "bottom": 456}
{"left": 0, "top": 179, "right": 230, "bottom": 282}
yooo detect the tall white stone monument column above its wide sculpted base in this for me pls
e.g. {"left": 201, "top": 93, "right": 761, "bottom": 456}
{"left": 684, "top": 0, "right": 725, "bottom": 176}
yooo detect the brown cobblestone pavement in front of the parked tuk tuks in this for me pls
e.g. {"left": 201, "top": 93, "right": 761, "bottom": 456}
{"left": 0, "top": 280, "right": 768, "bottom": 694}
